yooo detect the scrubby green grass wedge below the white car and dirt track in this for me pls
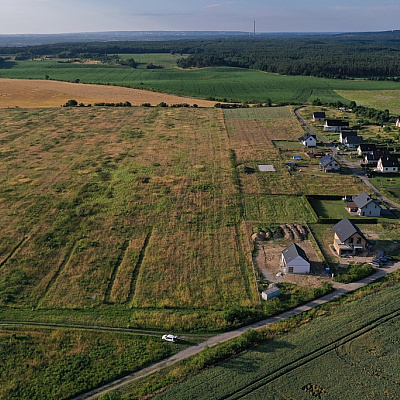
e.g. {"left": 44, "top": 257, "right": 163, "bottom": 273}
{"left": 0, "top": 327, "right": 178, "bottom": 400}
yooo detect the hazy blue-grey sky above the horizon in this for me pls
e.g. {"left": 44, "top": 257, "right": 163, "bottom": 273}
{"left": 0, "top": 0, "right": 400, "bottom": 34}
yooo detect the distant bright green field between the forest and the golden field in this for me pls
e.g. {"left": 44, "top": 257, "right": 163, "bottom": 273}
{"left": 0, "top": 55, "right": 400, "bottom": 104}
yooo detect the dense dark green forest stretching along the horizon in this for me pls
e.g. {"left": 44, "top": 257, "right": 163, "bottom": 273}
{"left": 0, "top": 31, "right": 400, "bottom": 80}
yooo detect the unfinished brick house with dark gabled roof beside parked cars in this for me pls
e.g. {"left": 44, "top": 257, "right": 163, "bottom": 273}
{"left": 333, "top": 218, "right": 368, "bottom": 256}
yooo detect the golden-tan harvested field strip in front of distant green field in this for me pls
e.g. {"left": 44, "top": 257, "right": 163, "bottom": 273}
{"left": 0, "top": 79, "right": 215, "bottom": 108}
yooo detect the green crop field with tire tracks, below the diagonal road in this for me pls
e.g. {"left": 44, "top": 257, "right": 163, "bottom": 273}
{"left": 154, "top": 285, "right": 400, "bottom": 400}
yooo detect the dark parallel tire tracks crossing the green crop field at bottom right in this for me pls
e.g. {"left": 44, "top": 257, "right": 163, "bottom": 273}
{"left": 221, "top": 310, "right": 400, "bottom": 400}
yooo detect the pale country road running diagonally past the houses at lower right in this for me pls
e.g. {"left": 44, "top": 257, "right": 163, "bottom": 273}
{"left": 73, "top": 262, "right": 400, "bottom": 400}
